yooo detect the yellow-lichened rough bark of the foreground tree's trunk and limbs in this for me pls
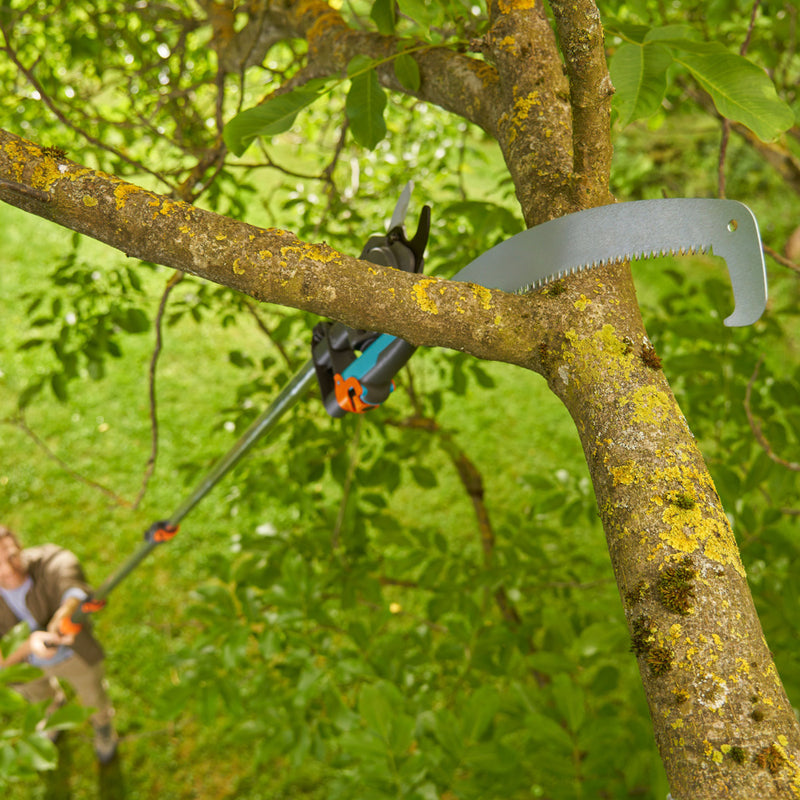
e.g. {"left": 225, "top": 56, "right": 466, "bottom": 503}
{"left": 0, "top": 0, "right": 800, "bottom": 800}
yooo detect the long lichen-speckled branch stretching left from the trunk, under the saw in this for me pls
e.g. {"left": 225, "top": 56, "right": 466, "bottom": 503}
{"left": 0, "top": 131, "right": 552, "bottom": 369}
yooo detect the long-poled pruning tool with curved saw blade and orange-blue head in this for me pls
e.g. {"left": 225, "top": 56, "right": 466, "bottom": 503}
{"left": 60, "top": 188, "right": 767, "bottom": 633}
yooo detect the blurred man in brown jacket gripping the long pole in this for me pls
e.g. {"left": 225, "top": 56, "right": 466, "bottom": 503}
{"left": 0, "top": 525, "right": 117, "bottom": 764}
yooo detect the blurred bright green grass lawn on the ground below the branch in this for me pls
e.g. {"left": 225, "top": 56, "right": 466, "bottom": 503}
{"left": 0, "top": 206, "right": 588, "bottom": 798}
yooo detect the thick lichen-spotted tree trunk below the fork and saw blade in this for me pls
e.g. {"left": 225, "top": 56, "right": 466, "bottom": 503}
{"left": 544, "top": 260, "right": 800, "bottom": 800}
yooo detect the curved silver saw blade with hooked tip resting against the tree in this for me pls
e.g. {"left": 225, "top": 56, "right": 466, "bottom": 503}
{"left": 453, "top": 198, "right": 767, "bottom": 326}
